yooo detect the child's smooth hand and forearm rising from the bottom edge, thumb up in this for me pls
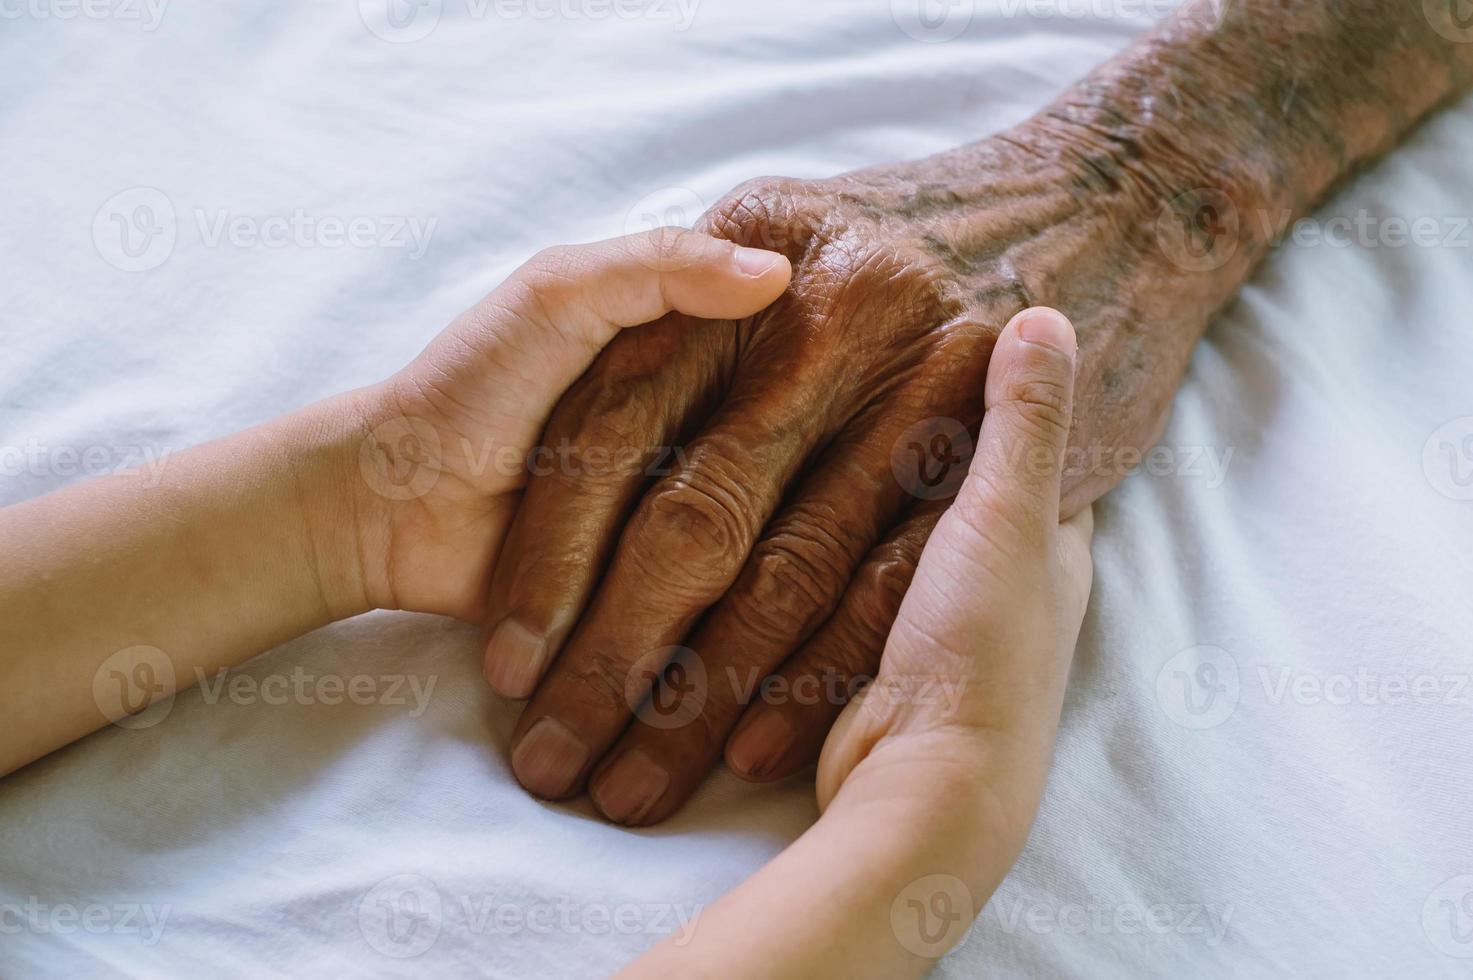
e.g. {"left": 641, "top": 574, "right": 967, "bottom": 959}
{"left": 625, "top": 309, "right": 1091, "bottom": 980}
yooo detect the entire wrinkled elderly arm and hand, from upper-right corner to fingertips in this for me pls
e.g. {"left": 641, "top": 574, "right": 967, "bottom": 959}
{"left": 486, "top": 0, "right": 1473, "bottom": 824}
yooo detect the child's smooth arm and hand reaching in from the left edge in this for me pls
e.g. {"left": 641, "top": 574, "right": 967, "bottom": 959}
{"left": 0, "top": 230, "right": 791, "bottom": 774}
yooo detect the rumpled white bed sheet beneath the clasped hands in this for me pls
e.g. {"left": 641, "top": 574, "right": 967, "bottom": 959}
{"left": 0, "top": 0, "right": 1473, "bottom": 977}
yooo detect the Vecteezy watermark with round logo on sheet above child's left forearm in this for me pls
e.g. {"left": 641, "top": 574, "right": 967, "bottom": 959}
{"left": 93, "top": 187, "right": 439, "bottom": 273}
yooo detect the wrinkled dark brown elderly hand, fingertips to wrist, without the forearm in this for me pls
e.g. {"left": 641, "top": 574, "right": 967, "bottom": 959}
{"left": 486, "top": 118, "right": 1209, "bottom": 822}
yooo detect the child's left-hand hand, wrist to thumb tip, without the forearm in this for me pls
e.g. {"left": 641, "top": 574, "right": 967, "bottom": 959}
{"left": 352, "top": 228, "right": 791, "bottom": 622}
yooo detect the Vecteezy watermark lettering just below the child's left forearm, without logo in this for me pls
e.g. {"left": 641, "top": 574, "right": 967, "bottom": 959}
{"left": 194, "top": 665, "right": 439, "bottom": 718}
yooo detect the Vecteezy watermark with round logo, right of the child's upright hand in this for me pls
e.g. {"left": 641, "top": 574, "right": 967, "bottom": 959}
{"left": 1156, "top": 645, "right": 1473, "bottom": 729}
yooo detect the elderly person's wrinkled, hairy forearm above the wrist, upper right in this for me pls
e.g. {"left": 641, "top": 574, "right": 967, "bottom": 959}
{"left": 1009, "top": 0, "right": 1473, "bottom": 308}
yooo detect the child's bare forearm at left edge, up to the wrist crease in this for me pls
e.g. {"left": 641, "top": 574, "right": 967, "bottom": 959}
{"left": 0, "top": 395, "right": 374, "bottom": 774}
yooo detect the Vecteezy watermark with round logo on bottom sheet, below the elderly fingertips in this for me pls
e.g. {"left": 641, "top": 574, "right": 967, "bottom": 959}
{"left": 358, "top": 874, "right": 706, "bottom": 959}
